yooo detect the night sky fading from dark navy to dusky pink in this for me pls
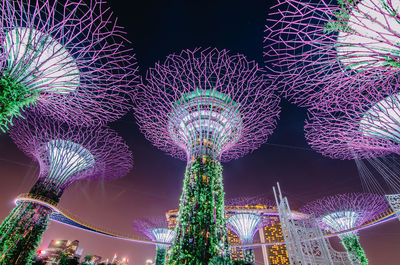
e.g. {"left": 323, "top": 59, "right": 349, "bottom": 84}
{"left": 0, "top": 0, "right": 400, "bottom": 265}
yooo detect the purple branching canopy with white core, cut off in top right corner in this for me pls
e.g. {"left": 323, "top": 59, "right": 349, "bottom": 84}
{"left": 264, "top": 0, "right": 400, "bottom": 107}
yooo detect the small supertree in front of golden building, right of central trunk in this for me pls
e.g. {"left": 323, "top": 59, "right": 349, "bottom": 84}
{"left": 226, "top": 197, "right": 274, "bottom": 264}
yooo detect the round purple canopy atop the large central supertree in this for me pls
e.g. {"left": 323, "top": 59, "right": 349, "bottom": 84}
{"left": 136, "top": 49, "right": 280, "bottom": 161}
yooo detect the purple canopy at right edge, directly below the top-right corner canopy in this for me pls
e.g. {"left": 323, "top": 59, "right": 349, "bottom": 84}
{"left": 305, "top": 87, "right": 400, "bottom": 159}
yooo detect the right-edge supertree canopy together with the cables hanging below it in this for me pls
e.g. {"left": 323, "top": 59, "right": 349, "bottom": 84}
{"left": 305, "top": 85, "right": 400, "bottom": 207}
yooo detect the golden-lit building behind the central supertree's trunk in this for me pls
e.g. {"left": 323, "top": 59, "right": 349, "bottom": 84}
{"left": 166, "top": 204, "right": 290, "bottom": 265}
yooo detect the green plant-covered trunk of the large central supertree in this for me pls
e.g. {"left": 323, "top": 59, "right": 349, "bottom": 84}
{"left": 168, "top": 156, "right": 228, "bottom": 265}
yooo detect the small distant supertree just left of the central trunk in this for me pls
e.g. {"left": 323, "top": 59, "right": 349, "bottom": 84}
{"left": 132, "top": 218, "right": 175, "bottom": 265}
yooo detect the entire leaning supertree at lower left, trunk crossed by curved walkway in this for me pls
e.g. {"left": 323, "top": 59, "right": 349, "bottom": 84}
{"left": 0, "top": 112, "right": 132, "bottom": 265}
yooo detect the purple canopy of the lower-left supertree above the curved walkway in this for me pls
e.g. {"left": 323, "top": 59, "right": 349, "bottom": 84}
{"left": 10, "top": 112, "right": 132, "bottom": 190}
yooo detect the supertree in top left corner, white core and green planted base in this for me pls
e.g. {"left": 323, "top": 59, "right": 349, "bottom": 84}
{"left": 0, "top": 0, "right": 139, "bottom": 131}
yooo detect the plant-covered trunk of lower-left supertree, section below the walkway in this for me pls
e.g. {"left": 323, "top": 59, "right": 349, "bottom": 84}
{"left": 0, "top": 202, "right": 51, "bottom": 265}
